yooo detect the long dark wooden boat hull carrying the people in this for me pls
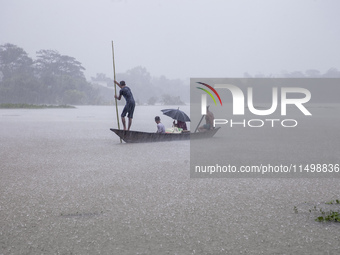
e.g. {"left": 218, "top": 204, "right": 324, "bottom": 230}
{"left": 110, "top": 127, "right": 220, "bottom": 143}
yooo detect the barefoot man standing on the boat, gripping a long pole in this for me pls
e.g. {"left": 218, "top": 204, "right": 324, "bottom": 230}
{"left": 115, "top": 81, "right": 135, "bottom": 130}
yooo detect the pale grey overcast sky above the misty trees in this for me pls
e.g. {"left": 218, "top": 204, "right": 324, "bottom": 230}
{"left": 0, "top": 0, "right": 340, "bottom": 79}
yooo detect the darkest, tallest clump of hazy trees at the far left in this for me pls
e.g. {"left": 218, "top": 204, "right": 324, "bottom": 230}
{"left": 0, "top": 43, "right": 100, "bottom": 104}
